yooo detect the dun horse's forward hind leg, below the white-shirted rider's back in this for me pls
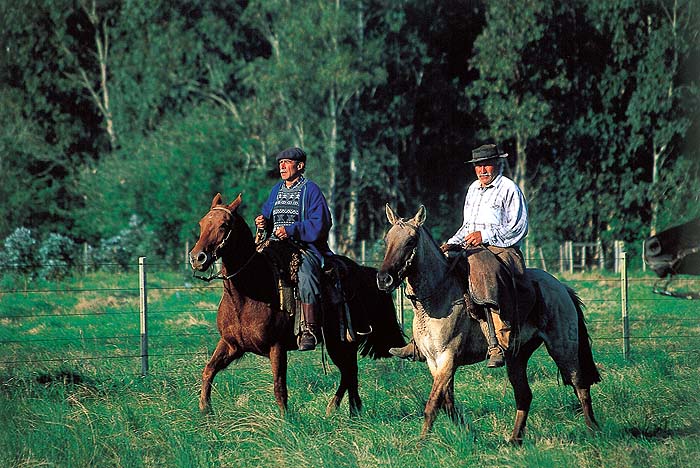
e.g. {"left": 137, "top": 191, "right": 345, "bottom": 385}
{"left": 506, "top": 338, "right": 542, "bottom": 445}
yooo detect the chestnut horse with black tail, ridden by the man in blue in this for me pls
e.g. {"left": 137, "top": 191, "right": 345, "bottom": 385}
{"left": 190, "top": 194, "right": 405, "bottom": 415}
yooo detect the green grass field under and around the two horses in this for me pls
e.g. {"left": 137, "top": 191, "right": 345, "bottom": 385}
{"left": 0, "top": 271, "right": 700, "bottom": 468}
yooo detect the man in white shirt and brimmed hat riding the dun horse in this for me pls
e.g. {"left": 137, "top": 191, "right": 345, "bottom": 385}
{"left": 390, "top": 144, "right": 528, "bottom": 367}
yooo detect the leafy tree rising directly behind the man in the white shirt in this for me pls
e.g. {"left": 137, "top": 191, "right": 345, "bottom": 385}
{"left": 466, "top": 0, "right": 571, "bottom": 194}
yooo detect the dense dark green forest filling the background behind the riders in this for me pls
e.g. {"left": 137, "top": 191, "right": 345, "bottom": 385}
{"left": 0, "top": 0, "right": 700, "bottom": 268}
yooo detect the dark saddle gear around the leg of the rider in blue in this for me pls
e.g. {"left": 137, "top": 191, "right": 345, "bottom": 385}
{"left": 256, "top": 239, "right": 371, "bottom": 342}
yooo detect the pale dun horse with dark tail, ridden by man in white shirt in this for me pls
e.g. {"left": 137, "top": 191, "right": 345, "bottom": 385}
{"left": 377, "top": 205, "right": 600, "bottom": 443}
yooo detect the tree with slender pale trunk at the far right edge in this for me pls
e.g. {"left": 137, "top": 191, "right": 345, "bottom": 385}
{"left": 626, "top": 0, "right": 700, "bottom": 235}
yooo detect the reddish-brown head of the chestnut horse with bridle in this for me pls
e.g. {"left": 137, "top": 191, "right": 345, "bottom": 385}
{"left": 190, "top": 193, "right": 244, "bottom": 271}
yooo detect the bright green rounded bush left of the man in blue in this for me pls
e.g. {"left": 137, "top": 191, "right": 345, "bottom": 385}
{"left": 77, "top": 102, "right": 271, "bottom": 263}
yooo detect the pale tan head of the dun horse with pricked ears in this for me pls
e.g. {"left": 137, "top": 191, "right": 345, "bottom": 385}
{"left": 377, "top": 204, "right": 426, "bottom": 291}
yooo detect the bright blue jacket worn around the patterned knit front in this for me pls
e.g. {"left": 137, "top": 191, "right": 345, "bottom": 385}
{"left": 262, "top": 179, "right": 333, "bottom": 258}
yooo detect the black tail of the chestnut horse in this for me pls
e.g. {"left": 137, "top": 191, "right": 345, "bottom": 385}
{"left": 358, "top": 267, "right": 406, "bottom": 359}
